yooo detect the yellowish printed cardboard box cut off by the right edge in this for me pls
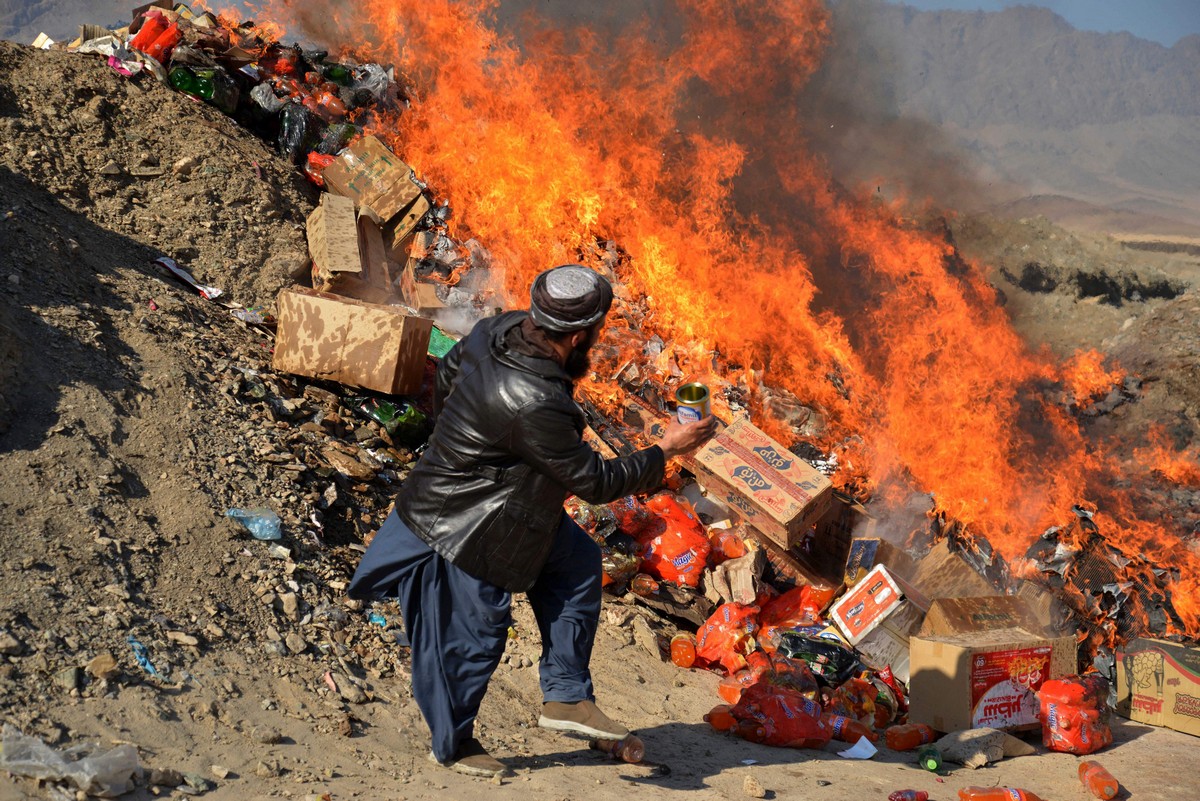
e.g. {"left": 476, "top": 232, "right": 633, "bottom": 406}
{"left": 1116, "top": 638, "right": 1200, "bottom": 735}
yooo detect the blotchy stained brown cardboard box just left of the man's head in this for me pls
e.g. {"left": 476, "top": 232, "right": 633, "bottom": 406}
{"left": 274, "top": 287, "right": 433, "bottom": 395}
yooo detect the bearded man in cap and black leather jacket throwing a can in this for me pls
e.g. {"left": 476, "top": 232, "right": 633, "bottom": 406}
{"left": 349, "top": 265, "right": 715, "bottom": 777}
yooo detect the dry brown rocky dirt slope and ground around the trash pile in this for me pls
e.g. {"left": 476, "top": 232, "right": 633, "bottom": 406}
{"left": 0, "top": 42, "right": 1200, "bottom": 801}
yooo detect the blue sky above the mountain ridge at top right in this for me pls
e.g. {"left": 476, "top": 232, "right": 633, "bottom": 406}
{"left": 890, "top": 0, "right": 1200, "bottom": 46}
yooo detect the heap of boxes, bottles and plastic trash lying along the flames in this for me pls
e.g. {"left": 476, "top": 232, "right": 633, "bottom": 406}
{"left": 14, "top": 2, "right": 1200, "bottom": 796}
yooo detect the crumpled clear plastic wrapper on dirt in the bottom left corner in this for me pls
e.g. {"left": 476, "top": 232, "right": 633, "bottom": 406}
{"left": 0, "top": 723, "right": 142, "bottom": 797}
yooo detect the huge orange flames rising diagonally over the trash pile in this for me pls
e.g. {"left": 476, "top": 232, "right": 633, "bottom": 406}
{"left": 238, "top": 0, "right": 1200, "bottom": 633}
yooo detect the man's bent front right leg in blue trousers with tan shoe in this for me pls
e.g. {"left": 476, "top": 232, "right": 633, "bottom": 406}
{"left": 528, "top": 513, "right": 629, "bottom": 739}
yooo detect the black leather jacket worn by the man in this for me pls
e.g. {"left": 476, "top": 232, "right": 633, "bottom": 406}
{"left": 396, "top": 312, "right": 666, "bottom": 592}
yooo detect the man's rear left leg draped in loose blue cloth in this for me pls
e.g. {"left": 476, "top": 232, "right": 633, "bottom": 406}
{"left": 371, "top": 513, "right": 511, "bottom": 764}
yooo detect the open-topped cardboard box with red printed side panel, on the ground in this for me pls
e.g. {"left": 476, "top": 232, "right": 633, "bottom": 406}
{"left": 908, "top": 597, "right": 1076, "bottom": 731}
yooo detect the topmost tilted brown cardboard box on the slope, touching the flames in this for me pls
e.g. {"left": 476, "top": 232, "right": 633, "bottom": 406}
{"left": 322, "top": 137, "right": 421, "bottom": 225}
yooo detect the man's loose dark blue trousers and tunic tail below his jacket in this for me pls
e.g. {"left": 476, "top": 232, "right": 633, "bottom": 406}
{"left": 350, "top": 512, "right": 601, "bottom": 761}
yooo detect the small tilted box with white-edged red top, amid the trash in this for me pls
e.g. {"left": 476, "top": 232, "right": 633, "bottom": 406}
{"left": 829, "top": 565, "right": 929, "bottom": 681}
